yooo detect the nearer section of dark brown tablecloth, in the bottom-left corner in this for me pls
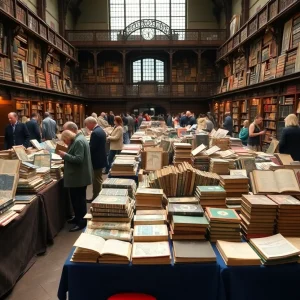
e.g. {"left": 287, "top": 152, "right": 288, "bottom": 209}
{"left": 0, "top": 197, "right": 47, "bottom": 297}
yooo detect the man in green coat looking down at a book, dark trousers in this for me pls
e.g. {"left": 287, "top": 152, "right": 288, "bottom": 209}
{"left": 59, "top": 122, "right": 93, "bottom": 232}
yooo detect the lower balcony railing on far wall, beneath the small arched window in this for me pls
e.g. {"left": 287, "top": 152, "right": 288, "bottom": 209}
{"left": 81, "top": 82, "right": 218, "bottom": 98}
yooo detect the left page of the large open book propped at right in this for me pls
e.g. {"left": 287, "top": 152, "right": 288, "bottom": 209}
{"left": 253, "top": 170, "right": 279, "bottom": 193}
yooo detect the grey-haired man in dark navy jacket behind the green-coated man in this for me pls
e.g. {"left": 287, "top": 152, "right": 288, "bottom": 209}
{"left": 85, "top": 117, "right": 107, "bottom": 202}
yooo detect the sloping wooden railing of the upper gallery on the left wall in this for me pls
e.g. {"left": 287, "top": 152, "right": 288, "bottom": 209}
{"left": 0, "top": 0, "right": 75, "bottom": 60}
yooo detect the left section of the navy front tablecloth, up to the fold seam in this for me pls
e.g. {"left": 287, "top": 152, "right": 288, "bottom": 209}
{"left": 58, "top": 249, "right": 220, "bottom": 300}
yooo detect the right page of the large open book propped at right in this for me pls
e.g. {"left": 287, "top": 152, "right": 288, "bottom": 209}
{"left": 274, "top": 170, "right": 300, "bottom": 193}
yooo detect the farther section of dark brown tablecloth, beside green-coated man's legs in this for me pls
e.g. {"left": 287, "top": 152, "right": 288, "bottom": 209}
{"left": 38, "top": 179, "right": 69, "bottom": 243}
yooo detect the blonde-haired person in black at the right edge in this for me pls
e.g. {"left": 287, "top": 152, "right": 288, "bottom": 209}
{"left": 279, "top": 114, "right": 300, "bottom": 161}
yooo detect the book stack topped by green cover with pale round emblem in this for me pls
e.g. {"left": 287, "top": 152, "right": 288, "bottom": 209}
{"left": 205, "top": 207, "right": 241, "bottom": 242}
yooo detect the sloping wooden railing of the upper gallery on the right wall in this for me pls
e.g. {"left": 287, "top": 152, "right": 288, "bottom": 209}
{"left": 217, "top": 0, "right": 300, "bottom": 61}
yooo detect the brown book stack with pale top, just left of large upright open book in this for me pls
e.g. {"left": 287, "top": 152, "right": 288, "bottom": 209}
{"left": 220, "top": 175, "right": 249, "bottom": 197}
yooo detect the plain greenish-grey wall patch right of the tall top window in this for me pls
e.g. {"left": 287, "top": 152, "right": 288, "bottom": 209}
{"left": 187, "top": 0, "right": 220, "bottom": 29}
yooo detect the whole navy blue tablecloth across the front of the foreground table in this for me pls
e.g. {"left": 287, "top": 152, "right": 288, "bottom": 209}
{"left": 58, "top": 246, "right": 300, "bottom": 300}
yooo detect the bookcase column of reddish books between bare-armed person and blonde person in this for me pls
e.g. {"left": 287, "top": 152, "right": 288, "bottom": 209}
{"left": 262, "top": 97, "right": 277, "bottom": 143}
